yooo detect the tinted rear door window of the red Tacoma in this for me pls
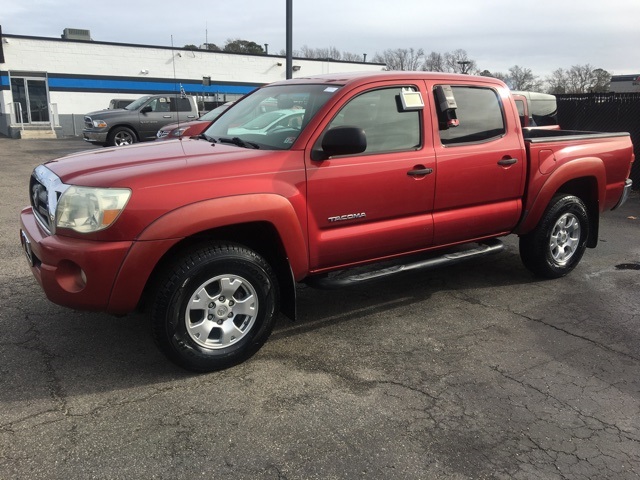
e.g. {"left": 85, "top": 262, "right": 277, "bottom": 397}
{"left": 440, "top": 86, "right": 506, "bottom": 145}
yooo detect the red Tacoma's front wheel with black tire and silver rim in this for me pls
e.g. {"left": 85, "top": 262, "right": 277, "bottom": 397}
{"left": 151, "top": 244, "right": 279, "bottom": 372}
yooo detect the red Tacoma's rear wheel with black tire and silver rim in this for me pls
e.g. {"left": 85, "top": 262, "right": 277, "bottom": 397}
{"left": 520, "top": 194, "right": 589, "bottom": 278}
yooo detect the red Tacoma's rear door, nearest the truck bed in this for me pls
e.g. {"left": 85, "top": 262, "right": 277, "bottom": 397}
{"left": 432, "top": 83, "right": 526, "bottom": 245}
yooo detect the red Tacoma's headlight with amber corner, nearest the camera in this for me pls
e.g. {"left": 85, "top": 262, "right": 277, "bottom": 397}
{"left": 56, "top": 186, "right": 131, "bottom": 233}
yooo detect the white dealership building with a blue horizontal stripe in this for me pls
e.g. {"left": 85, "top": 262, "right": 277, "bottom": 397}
{"left": 0, "top": 29, "right": 384, "bottom": 137}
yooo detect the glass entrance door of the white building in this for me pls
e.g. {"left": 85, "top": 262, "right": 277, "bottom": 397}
{"left": 11, "top": 77, "right": 49, "bottom": 124}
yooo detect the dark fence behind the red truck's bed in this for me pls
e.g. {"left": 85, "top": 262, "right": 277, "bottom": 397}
{"left": 556, "top": 93, "right": 640, "bottom": 190}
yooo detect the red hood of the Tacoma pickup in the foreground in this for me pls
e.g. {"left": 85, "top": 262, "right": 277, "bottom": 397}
{"left": 46, "top": 139, "right": 277, "bottom": 187}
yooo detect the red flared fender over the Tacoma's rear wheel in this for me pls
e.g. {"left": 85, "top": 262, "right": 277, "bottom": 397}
{"left": 514, "top": 157, "right": 607, "bottom": 235}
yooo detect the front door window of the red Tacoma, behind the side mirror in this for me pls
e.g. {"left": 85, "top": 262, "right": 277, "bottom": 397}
{"left": 328, "top": 87, "right": 421, "bottom": 154}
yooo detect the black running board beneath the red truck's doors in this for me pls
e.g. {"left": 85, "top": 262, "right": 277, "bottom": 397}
{"left": 305, "top": 239, "right": 504, "bottom": 290}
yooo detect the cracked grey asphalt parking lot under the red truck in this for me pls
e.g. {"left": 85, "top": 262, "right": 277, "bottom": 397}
{"left": 0, "top": 138, "right": 640, "bottom": 480}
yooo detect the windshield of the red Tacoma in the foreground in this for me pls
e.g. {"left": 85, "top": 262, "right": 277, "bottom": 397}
{"left": 204, "top": 85, "right": 340, "bottom": 150}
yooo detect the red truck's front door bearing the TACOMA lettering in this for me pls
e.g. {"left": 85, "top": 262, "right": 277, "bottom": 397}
{"left": 306, "top": 84, "right": 435, "bottom": 271}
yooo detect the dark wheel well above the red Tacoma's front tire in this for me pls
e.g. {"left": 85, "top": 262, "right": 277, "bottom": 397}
{"left": 138, "top": 222, "right": 295, "bottom": 319}
